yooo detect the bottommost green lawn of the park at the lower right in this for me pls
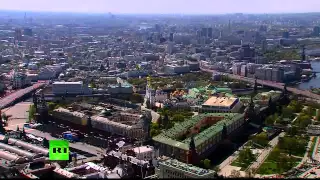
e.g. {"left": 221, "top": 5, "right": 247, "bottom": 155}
{"left": 257, "top": 157, "right": 301, "bottom": 175}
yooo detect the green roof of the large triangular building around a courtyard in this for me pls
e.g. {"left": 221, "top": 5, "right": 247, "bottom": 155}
{"left": 153, "top": 113, "right": 243, "bottom": 150}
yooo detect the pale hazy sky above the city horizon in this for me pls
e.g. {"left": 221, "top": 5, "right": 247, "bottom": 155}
{"left": 0, "top": 0, "right": 320, "bottom": 14}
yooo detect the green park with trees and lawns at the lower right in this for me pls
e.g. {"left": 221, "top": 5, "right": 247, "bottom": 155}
{"left": 257, "top": 100, "right": 317, "bottom": 175}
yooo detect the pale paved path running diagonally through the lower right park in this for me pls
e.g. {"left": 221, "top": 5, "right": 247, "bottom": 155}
{"left": 249, "top": 132, "right": 285, "bottom": 169}
